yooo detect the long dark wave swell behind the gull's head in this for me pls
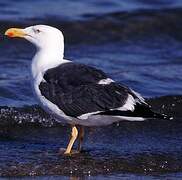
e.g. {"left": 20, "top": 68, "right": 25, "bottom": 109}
{"left": 1, "top": 8, "right": 182, "bottom": 43}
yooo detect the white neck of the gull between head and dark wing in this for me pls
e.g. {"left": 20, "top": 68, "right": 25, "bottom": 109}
{"left": 31, "top": 49, "right": 65, "bottom": 79}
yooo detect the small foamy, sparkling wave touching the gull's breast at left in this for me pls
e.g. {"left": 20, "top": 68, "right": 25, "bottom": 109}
{"left": 0, "top": 105, "right": 57, "bottom": 128}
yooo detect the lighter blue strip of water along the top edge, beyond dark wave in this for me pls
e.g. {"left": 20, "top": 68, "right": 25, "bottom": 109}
{"left": 0, "top": 0, "right": 182, "bottom": 21}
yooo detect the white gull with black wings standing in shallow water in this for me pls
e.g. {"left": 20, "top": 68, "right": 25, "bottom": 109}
{"left": 5, "top": 25, "right": 166, "bottom": 155}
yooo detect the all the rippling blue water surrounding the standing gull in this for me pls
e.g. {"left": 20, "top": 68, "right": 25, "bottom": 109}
{"left": 0, "top": 0, "right": 182, "bottom": 179}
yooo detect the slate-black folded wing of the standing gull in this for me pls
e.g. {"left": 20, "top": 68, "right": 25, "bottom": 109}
{"left": 39, "top": 63, "right": 145, "bottom": 117}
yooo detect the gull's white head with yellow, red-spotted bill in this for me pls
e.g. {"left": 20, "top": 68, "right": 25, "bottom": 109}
{"left": 5, "top": 25, "right": 64, "bottom": 50}
